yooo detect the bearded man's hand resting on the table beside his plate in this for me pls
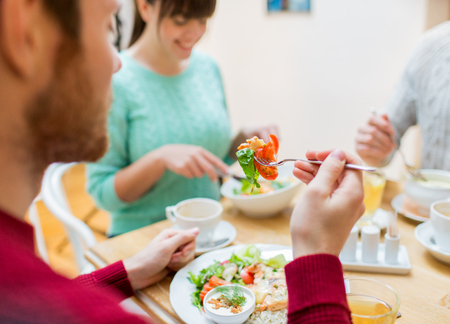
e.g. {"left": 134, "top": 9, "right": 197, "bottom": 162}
{"left": 123, "top": 228, "right": 199, "bottom": 290}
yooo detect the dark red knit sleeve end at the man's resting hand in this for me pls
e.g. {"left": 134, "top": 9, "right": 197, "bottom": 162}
{"left": 74, "top": 261, "right": 134, "bottom": 299}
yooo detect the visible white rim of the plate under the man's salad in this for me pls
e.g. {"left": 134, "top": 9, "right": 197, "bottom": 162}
{"left": 170, "top": 244, "right": 293, "bottom": 324}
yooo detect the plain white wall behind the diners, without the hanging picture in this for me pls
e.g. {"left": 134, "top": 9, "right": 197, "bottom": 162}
{"left": 120, "top": 0, "right": 450, "bottom": 180}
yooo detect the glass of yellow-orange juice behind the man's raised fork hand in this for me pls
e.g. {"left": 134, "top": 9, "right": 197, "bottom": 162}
{"left": 358, "top": 170, "right": 386, "bottom": 226}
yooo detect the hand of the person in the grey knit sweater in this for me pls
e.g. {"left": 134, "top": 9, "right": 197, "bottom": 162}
{"left": 356, "top": 114, "right": 396, "bottom": 166}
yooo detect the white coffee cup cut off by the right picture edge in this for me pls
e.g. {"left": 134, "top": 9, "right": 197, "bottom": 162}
{"left": 430, "top": 199, "right": 450, "bottom": 252}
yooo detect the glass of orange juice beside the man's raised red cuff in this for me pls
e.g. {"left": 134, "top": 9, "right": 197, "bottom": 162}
{"left": 345, "top": 277, "right": 400, "bottom": 324}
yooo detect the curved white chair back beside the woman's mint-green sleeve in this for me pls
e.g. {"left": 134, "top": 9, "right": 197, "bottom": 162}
{"left": 41, "top": 163, "right": 97, "bottom": 273}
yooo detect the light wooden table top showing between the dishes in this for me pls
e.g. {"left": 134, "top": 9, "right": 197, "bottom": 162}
{"left": 86, "top": 181, "right": 450, "bottom": 324}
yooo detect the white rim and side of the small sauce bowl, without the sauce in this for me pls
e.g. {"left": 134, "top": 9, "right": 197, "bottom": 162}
{"left": 203, "top": 285, "right": 256, "bottom": 324}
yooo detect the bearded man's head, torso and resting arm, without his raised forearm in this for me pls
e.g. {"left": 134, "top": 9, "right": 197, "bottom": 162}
{"left": 0, "top": 0, "right": 198, "bottom": 323}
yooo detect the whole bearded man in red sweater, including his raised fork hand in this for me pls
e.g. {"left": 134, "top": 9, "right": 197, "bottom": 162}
{"left": 0, "top": 0, "right": 364, "bottom": 323}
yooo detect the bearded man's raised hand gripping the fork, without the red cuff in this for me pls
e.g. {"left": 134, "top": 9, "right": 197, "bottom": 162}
{"left": 291, "top": 150, "right": 365, "bottom": 258}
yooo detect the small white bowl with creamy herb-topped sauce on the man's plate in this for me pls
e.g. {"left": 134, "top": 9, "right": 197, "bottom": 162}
{"left": 203, "top": 285, "right": 255, "bottom": 324}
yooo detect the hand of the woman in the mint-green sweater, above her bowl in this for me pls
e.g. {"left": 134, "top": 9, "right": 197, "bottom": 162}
{"left": 159, "top": 144, "right": 228, "bottom": 182}
